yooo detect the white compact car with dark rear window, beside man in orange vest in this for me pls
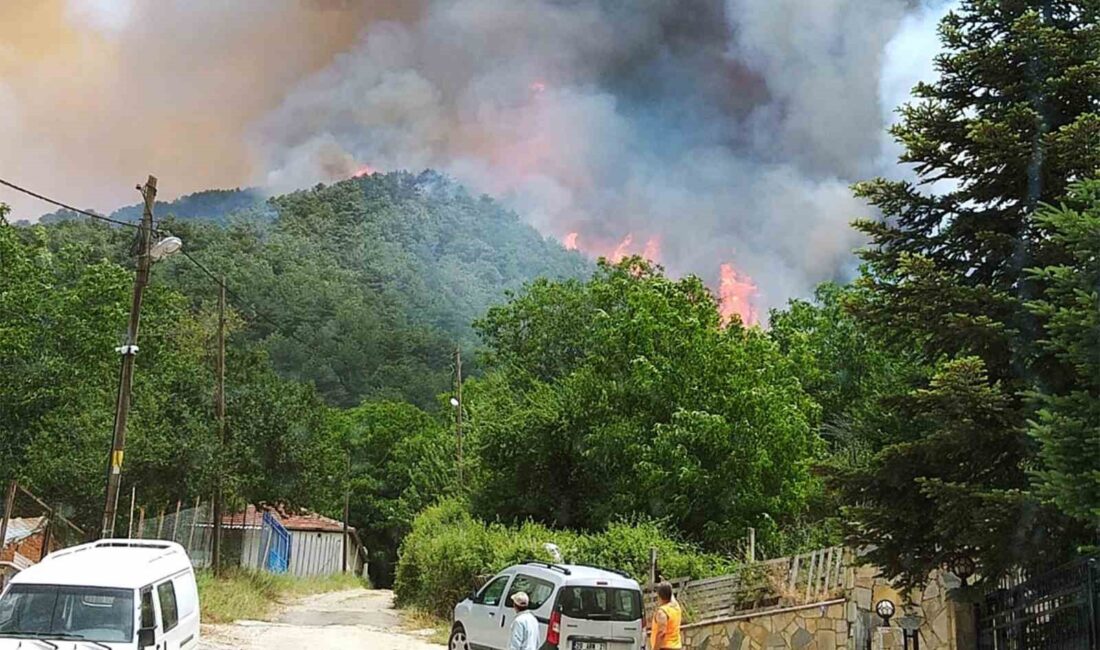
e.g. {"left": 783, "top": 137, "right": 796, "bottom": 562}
{"left": 450, "top": 562, "right": 645, "bottom": 650}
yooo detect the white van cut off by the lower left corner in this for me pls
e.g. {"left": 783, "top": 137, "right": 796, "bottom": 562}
{"left": 0, "top": 539, "right": 199, "bottom": 650}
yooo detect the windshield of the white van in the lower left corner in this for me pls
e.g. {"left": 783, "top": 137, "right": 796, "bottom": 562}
{"left": 0, "top": 584, "right": 134, "bottom": 643}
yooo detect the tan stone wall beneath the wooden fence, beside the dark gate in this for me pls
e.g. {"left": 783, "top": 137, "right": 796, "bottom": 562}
{"left": 684, "top": 566, "right": 968, "bottom": 650}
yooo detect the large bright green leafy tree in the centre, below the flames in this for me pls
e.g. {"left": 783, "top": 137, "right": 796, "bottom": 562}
{"left": 465, "top": 258, "right": 816, "bottom": 550}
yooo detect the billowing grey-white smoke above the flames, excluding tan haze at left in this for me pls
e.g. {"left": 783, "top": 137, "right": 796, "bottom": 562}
{"left": 252, "top": 0, "right": 946, "bottom": 307}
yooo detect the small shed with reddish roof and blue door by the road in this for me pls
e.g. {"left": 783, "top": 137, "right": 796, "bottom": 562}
{"left": 222, "top": 505, "right": 366, "bottom": 577}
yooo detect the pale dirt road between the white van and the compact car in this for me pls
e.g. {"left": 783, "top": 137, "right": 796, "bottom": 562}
{"left": 200, "top": 590, "right": 440, "bottom": 650}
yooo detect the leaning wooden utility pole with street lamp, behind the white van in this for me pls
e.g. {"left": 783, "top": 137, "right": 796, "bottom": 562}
{"left": 100, "top": 176, "right": 156, "bottom": 538}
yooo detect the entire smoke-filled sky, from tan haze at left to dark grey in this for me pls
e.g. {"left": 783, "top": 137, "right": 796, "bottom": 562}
{"left": 0, "top": 0, "right": 942, "bottom": 311}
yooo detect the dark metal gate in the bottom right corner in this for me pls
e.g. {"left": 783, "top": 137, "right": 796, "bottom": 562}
{"left": 978, "top": 559, "right": 1100, "bottom": 650}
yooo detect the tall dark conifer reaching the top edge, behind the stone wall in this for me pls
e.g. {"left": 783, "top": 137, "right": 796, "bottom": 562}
{"left": 834, "top": 0, "right": 1100, "bottom": 582}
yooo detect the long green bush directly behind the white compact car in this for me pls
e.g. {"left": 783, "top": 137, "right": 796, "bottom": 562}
{"left": 394, "top": 500, "right": 734, "bottom": 616}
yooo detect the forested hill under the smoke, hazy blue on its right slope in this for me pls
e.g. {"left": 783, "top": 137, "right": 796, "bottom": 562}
{"left": 34, "top": 172, "right": 591, "bottom": 407}
